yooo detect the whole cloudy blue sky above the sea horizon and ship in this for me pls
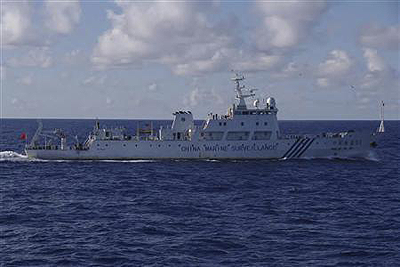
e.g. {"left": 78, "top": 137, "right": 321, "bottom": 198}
{"left": 0, "top": 0, "right": 400, "bottom": 120}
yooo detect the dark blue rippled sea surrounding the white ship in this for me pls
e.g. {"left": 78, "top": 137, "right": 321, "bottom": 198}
{"left": 0, "top": 120, "right": 400, "bottom": 266}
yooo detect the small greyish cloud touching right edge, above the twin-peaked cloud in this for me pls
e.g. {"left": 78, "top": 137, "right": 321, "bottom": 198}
{"left": 359, "top": 24, "right": 400, "bottom": 50}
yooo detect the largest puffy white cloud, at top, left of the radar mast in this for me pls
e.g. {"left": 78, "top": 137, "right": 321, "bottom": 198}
{"left": 92, "top": 2, "right": 233, "bottom": 73}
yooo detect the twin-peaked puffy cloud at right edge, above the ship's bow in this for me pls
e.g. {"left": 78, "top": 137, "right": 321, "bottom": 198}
{"left": 315, "top": 48, "right": 400, "bottom": 109}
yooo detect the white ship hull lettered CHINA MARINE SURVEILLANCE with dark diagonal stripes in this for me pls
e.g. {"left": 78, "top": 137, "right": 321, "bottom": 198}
{"left": 26, "top": 132, "right": 378, "bottom": 160}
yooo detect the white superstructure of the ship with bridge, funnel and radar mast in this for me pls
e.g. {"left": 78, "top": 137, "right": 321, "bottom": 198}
{"left": 155, "top": 75, "right": 280, "bottom": 141}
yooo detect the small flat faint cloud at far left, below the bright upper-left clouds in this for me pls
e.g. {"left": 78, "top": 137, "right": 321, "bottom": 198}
{"left": 7, "top": 47, "right": 53, "bottom": 68}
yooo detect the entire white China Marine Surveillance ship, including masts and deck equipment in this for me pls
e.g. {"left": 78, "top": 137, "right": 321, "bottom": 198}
{"left": 25, "top": 74, "right": 384, "bottom": 160}
